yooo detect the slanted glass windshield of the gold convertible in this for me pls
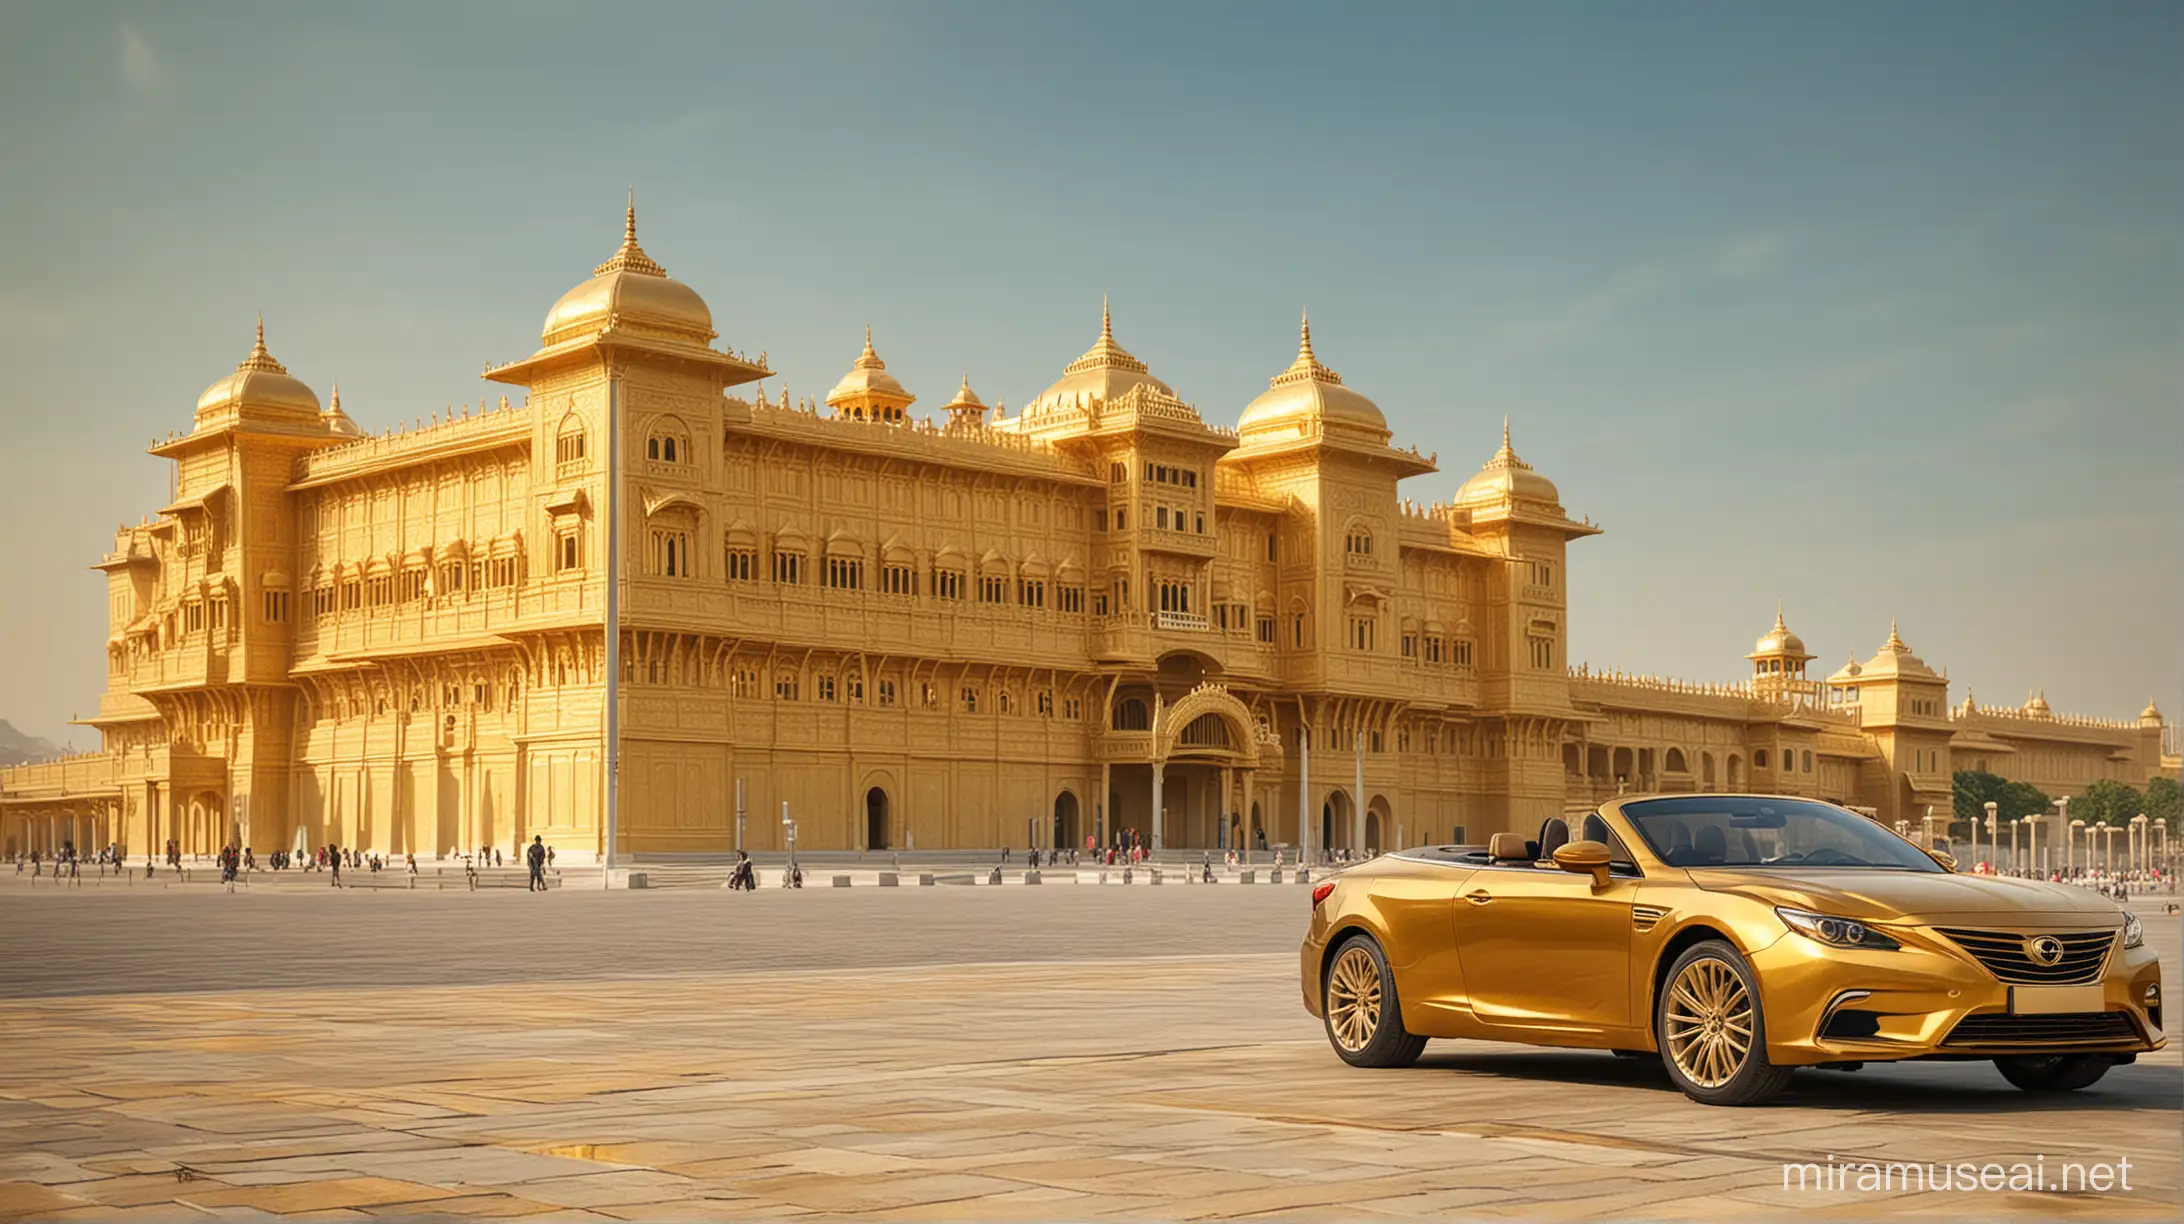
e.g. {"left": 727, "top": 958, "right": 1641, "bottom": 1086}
{"left": 1623, "top": 796, "right": 1942, "bottom": 872}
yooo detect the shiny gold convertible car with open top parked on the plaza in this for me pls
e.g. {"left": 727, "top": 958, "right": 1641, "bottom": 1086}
{"left": 1299, "top": 796, "right": 2162, "bottom": 1106}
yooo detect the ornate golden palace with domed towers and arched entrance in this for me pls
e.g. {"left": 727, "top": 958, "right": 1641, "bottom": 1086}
{"left": 0, "top": 210, "right": 2160, "bottom": 861}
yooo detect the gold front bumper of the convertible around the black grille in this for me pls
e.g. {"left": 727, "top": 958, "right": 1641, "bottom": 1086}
{"left": 1752, "top": 929, "right": 2167, "bottom": 1067}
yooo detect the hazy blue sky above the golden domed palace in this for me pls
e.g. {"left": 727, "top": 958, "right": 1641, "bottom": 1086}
{"left": 0, "top": 2, "right": 2184, "bottom": 748}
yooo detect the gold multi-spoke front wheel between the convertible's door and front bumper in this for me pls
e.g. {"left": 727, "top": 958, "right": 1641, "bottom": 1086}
{"left": 1653, "top": 940, "right": 1789, "bottom": 1106}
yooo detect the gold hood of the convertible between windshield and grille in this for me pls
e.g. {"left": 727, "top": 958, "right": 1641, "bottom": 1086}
{"left": 1690, "top": 868, "right": 2121, "bottom": 927}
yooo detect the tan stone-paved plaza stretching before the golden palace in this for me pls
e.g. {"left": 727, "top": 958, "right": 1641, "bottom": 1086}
{"left": 0, "top": 887, "right": 2184, "bottom": 1220}
